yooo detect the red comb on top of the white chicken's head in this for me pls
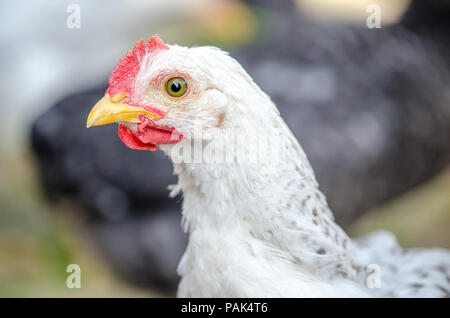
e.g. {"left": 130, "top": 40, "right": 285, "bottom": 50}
{"left": 106, "top": 34, "right": 169, "bottom": 96}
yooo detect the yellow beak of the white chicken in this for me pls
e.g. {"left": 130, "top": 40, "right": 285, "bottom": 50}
{"left": 86, "top": 93, "right": 161, "bottom": 128}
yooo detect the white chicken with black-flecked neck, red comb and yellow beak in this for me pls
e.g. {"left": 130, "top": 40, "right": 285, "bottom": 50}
{"left": 87, "top": 35, "right": 450, "bottom": 297}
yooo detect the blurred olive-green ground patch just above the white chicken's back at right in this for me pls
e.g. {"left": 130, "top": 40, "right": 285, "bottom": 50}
{"left": 350, "top": 169, "right": 450, "bottom": 248}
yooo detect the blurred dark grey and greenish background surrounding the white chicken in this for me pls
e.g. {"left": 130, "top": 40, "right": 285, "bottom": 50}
{"left": 0, "top": 0, "right": 450, "bottom": 297}
